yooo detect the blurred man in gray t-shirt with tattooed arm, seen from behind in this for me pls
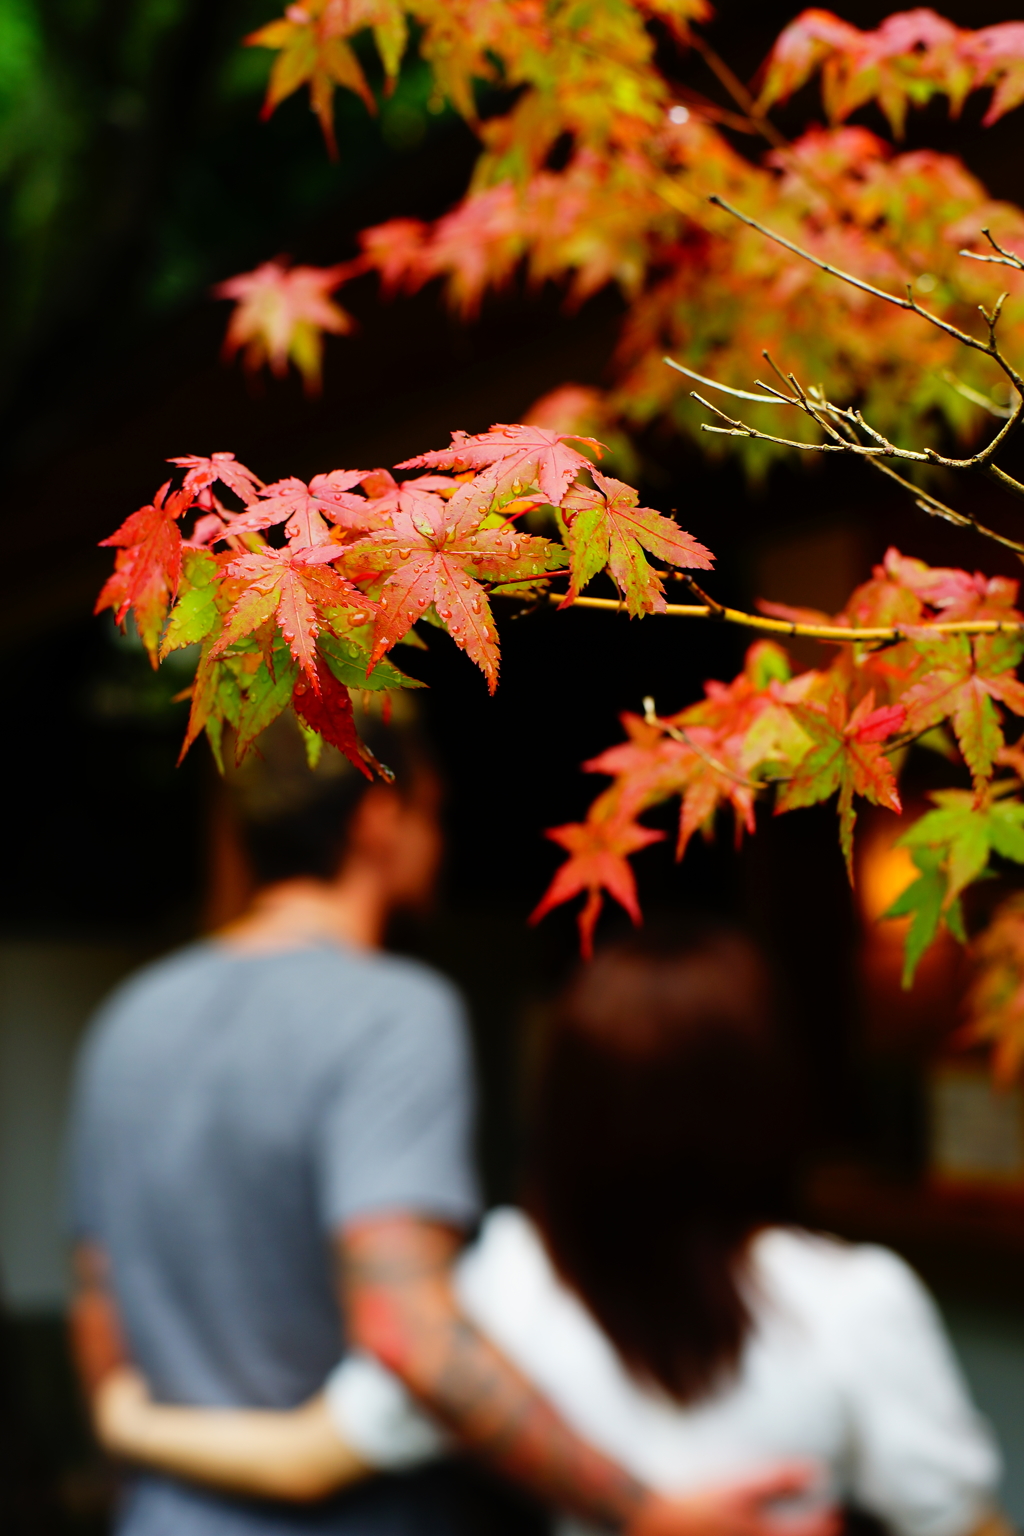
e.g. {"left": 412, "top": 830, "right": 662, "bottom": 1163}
{"left": 72, "top": 717, "right": 829, "bottom": 1536}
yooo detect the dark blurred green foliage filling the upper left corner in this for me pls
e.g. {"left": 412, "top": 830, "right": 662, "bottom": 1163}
{"left": 0, "top": 0, "right": 450, "bottom": 420}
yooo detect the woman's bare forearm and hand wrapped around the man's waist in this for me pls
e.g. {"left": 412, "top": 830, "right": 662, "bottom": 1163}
{"left": 92, "top": 1367, "right": 373, "bottom": 1502}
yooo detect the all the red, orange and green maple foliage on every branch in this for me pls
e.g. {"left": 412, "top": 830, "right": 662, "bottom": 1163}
{"left": 100, "top": 0, "right": 1024, "bottom": 1075}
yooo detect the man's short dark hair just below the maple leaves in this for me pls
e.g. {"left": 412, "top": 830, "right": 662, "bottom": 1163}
{"left": 226, "top": 711, "right": 431, "bottom": 885}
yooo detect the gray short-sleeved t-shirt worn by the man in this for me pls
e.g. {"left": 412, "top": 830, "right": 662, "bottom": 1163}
{"left": 72, "top": 943, "right": 477, "bottom": 1536}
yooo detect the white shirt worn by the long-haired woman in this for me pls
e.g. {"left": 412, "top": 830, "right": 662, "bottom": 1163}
{"left": 329, "top": 1209, "right": 999, "bottom": 1536}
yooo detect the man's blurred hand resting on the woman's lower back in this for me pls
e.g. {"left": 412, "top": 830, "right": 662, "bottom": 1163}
{"left": 626, "top": 1464, "right": 840, "bottom": 1536}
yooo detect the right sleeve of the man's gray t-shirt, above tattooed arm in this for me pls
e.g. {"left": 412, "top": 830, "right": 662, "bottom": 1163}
{"left": 316, "top": 977, "right": 479, "bottom": 1229}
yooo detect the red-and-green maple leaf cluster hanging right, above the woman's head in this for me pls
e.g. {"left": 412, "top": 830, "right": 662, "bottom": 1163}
{"left": 534, "top": 550, "right": 1024, "bottom": 980}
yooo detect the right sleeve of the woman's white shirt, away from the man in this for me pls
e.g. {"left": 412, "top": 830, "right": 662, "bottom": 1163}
{"left": 837, "top": 1249, "right": 1001, "bottom": 1536}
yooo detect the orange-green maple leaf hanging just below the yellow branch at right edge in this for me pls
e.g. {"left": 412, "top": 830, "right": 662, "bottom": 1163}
{"left": 903, "top": 634, "right": 1024, "bottom": 786}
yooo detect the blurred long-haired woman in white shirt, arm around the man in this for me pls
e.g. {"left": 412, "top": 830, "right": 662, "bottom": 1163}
{"left": 88, "top": 932, "right": 1010, "bottom": 1536}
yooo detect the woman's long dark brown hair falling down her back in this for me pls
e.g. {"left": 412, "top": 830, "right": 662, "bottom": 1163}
{"left": 527, "top": 931, "right": 794, "bottom": 1402}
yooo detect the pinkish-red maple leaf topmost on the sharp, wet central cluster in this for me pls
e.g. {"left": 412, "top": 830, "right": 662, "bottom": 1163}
{"left": 395, "top": 422, "right": 603, "bottom": 507}
